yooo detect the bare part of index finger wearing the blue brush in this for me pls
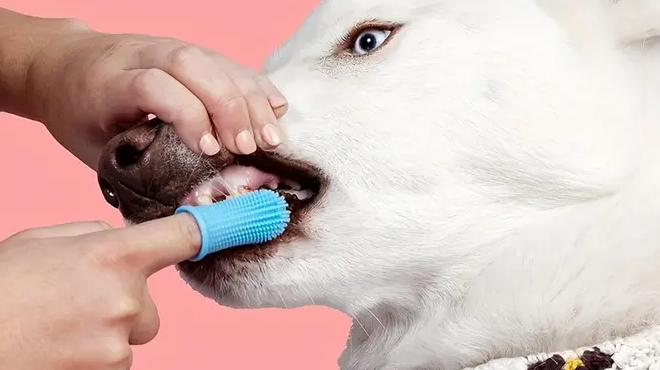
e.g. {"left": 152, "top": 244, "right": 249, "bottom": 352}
{"left": 91, "top": 213, "right": 202, "bottom": 276}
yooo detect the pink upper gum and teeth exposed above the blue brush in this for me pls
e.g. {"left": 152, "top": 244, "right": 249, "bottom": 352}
{"left": 181, "top": 165, "right": 280, "bottom": 205}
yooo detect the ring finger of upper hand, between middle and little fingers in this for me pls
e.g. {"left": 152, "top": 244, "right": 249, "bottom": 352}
{"left": 234, "top": 75, "right": 282, "bottom": 149}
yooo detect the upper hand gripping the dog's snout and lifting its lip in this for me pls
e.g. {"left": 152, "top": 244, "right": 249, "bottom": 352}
{"left": 28, "top": 28, "right": 287, "bottom": 169}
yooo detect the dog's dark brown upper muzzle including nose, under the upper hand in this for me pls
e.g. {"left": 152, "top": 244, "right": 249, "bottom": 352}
{"left": 98, "top": 119, "right": 233, "bottom": 222}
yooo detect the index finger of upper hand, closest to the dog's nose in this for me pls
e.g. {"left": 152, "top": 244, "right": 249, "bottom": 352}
{"left": 109, "top": 68, "right": 220, "bottom": 155}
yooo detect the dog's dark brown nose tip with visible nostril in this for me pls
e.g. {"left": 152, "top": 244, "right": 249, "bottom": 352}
{"left": 98, "top": 121, "right": 161, "bottom": 208}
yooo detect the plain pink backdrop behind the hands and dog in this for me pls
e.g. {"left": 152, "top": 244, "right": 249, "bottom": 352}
{"left": 0, "top": 0, "right": 349, "bottom": 370}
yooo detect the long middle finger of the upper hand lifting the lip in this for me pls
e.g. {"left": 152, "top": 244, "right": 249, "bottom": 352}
{"left": 136, "top": 45, "right": 256, "bottom": 154}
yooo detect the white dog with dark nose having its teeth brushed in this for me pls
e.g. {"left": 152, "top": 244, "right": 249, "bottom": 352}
{"left": 95, "top": 0, "right": 660, "bottom": 370}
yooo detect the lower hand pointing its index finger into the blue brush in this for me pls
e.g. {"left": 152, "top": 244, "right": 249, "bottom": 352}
{"left": 0, "top": 214, "right": 201, "bottom": 370}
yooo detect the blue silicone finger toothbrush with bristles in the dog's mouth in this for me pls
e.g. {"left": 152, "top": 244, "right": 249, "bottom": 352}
{"left": 175, "top": 189, "right": 291, "bottom": 261}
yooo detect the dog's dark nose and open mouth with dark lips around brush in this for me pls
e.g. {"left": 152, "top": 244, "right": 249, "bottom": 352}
{"left": 98, "top": 119, "right": 329, "bottom": 300}
